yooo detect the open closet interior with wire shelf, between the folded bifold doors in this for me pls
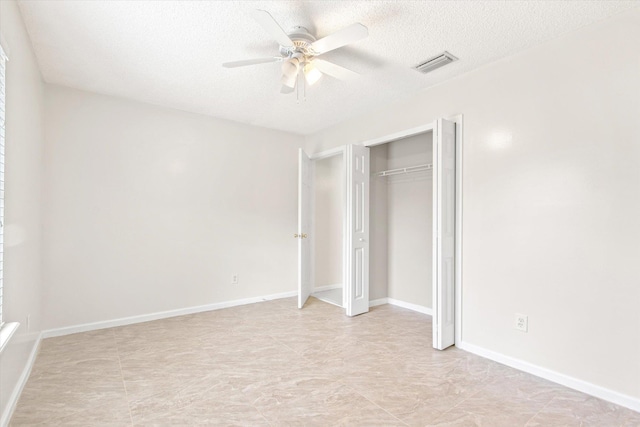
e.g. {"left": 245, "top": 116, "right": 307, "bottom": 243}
{"left": 369, "top": 131, "right": 433, "bottom": 314}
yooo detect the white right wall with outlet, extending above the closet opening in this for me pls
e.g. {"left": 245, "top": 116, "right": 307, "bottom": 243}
{"left": 308, "top": 9, "right": 640, "bottom": 399}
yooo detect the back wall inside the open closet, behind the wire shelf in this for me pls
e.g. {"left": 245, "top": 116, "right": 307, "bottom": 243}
{"left": 384, "top": 132, "right": 433, "bottom": 308}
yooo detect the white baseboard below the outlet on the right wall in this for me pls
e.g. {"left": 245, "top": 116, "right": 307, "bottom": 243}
{"left": 456, "top": 342, "right": 640, "bottom": 412}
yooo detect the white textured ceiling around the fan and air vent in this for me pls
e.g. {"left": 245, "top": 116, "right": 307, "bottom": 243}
{"left": 18, "top": 0, "right": 639, "bottom": 134}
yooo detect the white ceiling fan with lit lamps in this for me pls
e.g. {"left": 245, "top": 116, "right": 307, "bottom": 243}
{"left": 222, "top": 10, "right": 369, "bottom": 93}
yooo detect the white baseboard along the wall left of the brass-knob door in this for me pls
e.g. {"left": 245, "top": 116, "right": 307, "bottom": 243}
{"left": 42, "top": 291, "right": 298, "bottom": 338}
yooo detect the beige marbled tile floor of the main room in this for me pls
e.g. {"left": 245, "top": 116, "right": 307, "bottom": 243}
{"left": 11, "top": 298, "right": 640, "bottom": 427}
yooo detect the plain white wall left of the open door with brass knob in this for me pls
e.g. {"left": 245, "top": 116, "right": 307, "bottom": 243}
{"left": 44, "top": 86, "right": 303, "bottom": 328}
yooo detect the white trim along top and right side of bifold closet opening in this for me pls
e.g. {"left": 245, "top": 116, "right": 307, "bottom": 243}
{"left": 359, "top": 114, "right": 464, "bottom": 345}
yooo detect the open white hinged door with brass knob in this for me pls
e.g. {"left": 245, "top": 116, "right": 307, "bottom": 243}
{"left": 296, "top": 149, "right": 313, "bottom": 308}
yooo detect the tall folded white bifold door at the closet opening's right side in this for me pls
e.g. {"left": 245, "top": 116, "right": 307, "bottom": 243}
{"left": 433, "top": 119, "right": 456, "bottom": 350}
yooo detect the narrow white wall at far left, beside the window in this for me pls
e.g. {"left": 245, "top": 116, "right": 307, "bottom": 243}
{"left": 0, "top": 1, "right": 44, "bottom": 422}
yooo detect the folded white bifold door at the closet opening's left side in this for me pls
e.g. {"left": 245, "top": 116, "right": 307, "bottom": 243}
{"left": 344, "top": 145, "right": 369, "bottom": 316}
